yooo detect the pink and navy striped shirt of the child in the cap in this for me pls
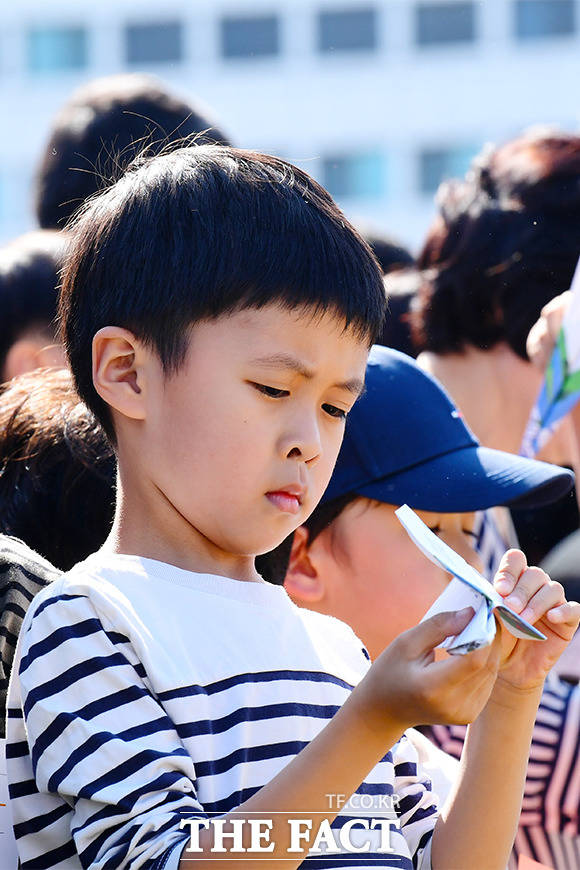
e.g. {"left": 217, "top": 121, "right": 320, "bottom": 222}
{"left": 422, "top": 674, "right": 580, "bottom": 870}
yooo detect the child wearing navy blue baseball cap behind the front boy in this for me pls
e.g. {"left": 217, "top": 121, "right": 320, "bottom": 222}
{"left": 260, "top": 347, "right": 580, "bottom": 867}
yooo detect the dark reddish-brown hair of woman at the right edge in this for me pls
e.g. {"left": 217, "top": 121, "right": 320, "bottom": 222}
{"left": 412, "top": 133, "right": 580, "bottom": 359}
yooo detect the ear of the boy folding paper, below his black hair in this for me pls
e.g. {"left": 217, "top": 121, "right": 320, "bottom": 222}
{"left": 93, "top": 326, "right": 149, "bottom": 420}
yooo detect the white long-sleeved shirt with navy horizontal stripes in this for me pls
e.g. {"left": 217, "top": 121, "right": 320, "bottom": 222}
{"left": 7, "top": 553, "right": 437, "bottom": 870}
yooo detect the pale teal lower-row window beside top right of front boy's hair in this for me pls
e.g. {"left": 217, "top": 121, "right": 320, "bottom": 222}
{"left": 322, "top": 151, "right": 385, "bottom": 199}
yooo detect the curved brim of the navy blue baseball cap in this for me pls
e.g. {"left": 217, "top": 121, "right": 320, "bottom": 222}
{"left": 352, "top": 446, "right": 574, "bottom": 513}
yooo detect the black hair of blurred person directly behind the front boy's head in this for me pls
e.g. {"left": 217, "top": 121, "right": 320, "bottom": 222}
{"left": 34, "top": 73, "right": 229, "bottom": 229}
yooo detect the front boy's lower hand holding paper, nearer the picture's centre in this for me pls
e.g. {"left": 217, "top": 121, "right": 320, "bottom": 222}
{"left": 355, "top": 607, "right": 501, "bottom": 731}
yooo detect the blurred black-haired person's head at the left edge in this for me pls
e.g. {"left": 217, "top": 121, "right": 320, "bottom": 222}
{"left": 0, "top": 230, "right": 66, "bottom": 381}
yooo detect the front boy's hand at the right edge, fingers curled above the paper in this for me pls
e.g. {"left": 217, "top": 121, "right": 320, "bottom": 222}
{"left": 493, "top": 550, "right": 580, "bottom": 690}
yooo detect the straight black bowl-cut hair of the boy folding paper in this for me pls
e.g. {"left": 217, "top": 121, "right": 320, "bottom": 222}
{"left": 59, "top": 145, "right": 385, "bottom": 442}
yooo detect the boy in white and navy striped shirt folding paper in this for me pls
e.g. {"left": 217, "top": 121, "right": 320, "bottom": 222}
{"left": 7, "top": 146, "right": 580, "bottom": 870}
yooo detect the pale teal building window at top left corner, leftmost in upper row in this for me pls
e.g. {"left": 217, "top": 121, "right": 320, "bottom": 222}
{"left": 27, "top": 27, "right": 87, "bottom": 72}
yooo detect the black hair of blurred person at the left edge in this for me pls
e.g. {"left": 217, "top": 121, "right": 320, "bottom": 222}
{"left": 0, "top": 230, "right": 65, "bottom": 380}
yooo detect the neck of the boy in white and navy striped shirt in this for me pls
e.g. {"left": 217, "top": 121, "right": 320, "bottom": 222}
{"left": 101, "top": 474, "right": 263, "bottom": 582}
